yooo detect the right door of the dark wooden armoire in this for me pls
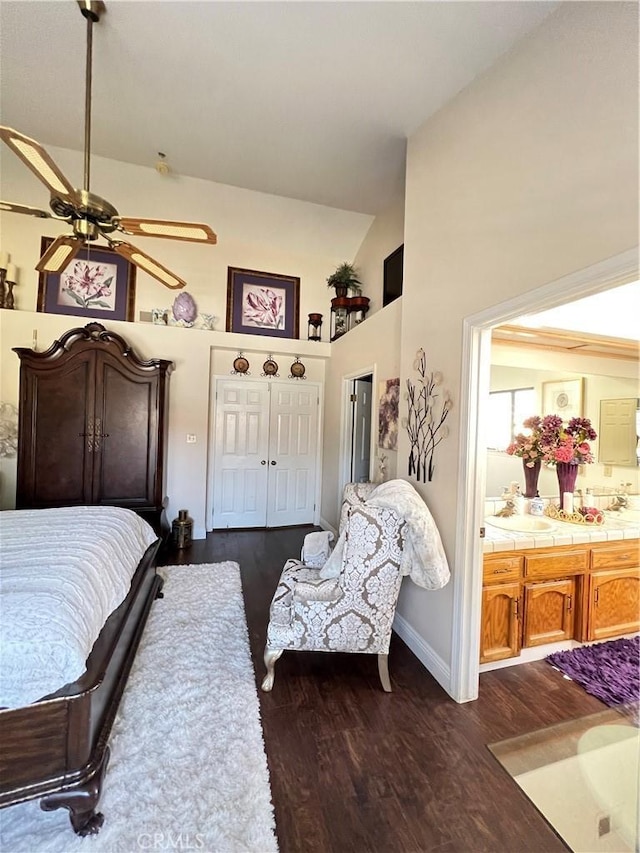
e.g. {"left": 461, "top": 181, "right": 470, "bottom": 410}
{"left": 94, "top": 360, "right": 158, "bottom": 506}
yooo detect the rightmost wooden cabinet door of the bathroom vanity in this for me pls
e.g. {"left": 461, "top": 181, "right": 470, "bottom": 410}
{"left": 589, "top": 568, "right": 640, "bottom": 640}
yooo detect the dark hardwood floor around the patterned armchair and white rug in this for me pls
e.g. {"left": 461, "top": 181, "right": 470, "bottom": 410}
{"left": 164, "top": 528, "right": 605, "bottom": 853}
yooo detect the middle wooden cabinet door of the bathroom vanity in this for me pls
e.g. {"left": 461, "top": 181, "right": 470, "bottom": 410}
{"left": 522, "top": 578, "right": 576, "bottom": 648}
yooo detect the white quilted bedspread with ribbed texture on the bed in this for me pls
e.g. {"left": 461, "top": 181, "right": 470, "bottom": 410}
{"left": 0, "top": 506, "right": 156, "bottom": 708}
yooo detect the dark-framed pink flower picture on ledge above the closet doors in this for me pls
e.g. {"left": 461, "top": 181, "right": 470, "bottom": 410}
{"left": 227, "top": 267, "right": 300, "bottom": 338}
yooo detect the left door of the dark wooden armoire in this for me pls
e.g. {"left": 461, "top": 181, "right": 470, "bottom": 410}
{"left": 16, "top": 358, "right": 94, "bottom": 508}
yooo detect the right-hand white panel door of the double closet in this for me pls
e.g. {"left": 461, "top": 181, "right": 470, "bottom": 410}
{"left": 267, "top": 382, "right": 319, "bottom": 527}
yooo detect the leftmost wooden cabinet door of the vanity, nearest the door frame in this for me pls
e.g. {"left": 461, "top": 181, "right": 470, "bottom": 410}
{"left": 480, "top": 583, "right": 520, "bottom": 663}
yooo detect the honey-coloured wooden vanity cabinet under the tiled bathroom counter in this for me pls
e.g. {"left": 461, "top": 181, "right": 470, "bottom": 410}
{"left": 480, "top": 539, "right": 640, "bottom": 663}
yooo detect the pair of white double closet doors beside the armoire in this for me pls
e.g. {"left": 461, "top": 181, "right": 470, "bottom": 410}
{"left": 213, "top": 379, "right": 319, "bottom": 528}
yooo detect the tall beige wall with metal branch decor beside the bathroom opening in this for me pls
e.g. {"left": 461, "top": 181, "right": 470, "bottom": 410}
{"left": 398, "top": 3, "right": 638, "bottom": 687}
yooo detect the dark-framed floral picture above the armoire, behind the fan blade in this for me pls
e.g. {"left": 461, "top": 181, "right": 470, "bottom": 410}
{"left": 37, "top": 237, "right": 136, "bottom": 321}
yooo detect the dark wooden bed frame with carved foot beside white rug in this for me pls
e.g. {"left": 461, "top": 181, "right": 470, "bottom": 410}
{"left": 0, "top": 540, "right": 163, "bottom": 835}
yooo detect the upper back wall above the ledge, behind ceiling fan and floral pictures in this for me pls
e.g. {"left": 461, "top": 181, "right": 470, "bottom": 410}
{"left": 0, "top": 145, "right": 373, "bottom": 328}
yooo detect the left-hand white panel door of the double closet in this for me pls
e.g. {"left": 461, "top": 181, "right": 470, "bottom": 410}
{"left": 213, "top": 380, "right": 269, "bottom": 528}
